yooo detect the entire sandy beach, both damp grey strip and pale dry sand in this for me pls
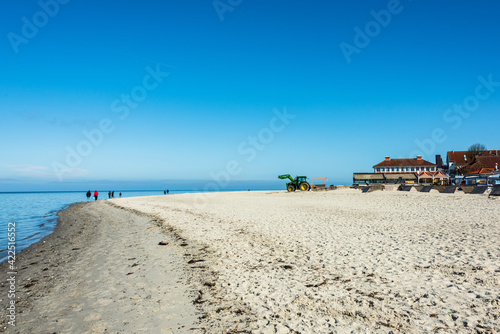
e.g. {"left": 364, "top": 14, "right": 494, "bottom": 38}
{"left": 0, "top": 189, "right": 500, "bottom": 333}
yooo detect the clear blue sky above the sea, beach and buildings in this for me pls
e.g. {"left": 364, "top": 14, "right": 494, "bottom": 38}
{"left": 0, "top": 0, "right": 500, "bottom": 191}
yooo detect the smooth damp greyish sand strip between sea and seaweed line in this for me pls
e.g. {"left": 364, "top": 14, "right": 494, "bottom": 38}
{"left": 0, "top": 201, "right": 202, "bottom": 333}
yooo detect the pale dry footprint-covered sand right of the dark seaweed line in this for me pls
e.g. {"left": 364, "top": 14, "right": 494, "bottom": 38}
{"left": 109, "top": 190, "right": 500, "bottom": 333}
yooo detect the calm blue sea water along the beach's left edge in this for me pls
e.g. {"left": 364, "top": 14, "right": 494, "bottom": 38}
{"left": 0, "top": 190, "right": 209, "bottom": 262}
